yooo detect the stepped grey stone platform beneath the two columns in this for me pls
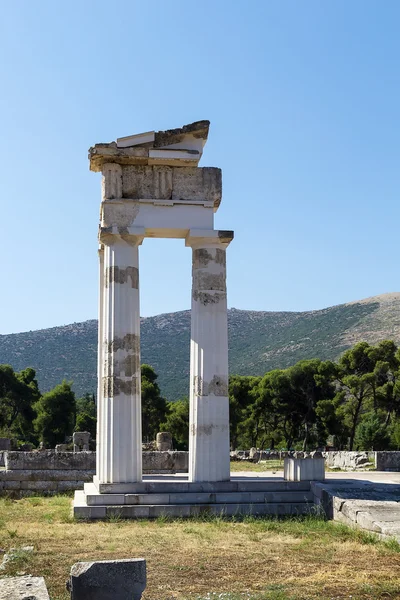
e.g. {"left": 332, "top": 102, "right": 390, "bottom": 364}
{"left": 73, "top": 475, "right": 314, "bottom": 519}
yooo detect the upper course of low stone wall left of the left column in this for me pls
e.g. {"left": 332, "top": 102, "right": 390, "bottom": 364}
{"left": 5, "top": 450, "right": 96, "bottom": 471}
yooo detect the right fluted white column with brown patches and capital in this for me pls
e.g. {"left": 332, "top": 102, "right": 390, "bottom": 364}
{"left": 186, "top": 229, "right": 233, "bottom": 482}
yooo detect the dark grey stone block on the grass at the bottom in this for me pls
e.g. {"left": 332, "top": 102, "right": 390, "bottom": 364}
{"left": 67, "top": 558, "right": 146, "bottom": 600}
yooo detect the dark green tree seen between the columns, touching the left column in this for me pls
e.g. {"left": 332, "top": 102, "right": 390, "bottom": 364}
{"left": 141, "top": 365, "right": 168, "bottom": 441}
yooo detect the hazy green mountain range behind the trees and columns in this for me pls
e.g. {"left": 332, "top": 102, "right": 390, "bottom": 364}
{"left": 0, "top": 293, "right": 400, "bottom": 400}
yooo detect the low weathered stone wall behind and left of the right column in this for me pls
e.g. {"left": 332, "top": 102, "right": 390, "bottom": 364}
{"left": 0, "top": 450, "right": 189, "bottom": 495}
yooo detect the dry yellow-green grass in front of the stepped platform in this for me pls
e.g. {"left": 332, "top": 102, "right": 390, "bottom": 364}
{"left": 0, "top": 496, "right": 400, "bottom": 600}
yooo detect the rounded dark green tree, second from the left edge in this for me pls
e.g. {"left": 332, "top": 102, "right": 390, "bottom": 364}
{"left": 34, "top": 381, "right": 76, "bottom": 448}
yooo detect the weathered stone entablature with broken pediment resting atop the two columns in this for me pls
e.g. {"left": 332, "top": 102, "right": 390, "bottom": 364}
{"left": 95, "top": 121, "right": 222, "bottom": 239}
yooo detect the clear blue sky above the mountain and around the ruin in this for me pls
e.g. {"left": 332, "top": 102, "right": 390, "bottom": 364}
{"left": 0, "top": 0, "right": 400, "bottom": 333}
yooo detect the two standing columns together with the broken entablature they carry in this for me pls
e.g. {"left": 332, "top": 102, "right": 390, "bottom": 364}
{"left": 76, "top": 121, "right": 233, "bottom": 516}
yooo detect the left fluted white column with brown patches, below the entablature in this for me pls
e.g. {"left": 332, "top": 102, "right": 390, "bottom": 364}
{"left": 96, "top": 231, "right": 144, "bottom": 483}
